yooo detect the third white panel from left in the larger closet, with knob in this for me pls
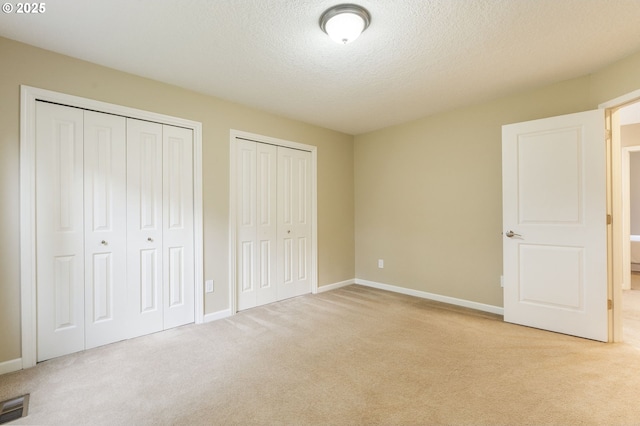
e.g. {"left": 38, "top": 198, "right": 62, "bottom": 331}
{"left": 127, "top": 119, "right": 163, "bottom": 337}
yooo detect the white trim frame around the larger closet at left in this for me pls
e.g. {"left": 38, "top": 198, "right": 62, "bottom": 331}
{"left": 20, "top": 85, "right": 204, "bottom": 369}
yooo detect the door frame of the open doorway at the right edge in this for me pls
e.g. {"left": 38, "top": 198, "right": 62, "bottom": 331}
{"left": 598, "top": 90, "right": 640, "bottom": 342}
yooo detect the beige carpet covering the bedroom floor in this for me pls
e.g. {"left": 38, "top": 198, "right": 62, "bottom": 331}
{"left": 0, "top": 285, "right": 640, "bottom": 425}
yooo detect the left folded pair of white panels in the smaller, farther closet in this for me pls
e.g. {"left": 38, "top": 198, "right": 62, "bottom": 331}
{"left": 236, "top": 139, "right": 278, "bottom": 310}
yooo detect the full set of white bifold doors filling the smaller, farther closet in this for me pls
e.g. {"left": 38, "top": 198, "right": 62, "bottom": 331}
{"left": 236, "top": 139, "right": 311, "bottom": 310}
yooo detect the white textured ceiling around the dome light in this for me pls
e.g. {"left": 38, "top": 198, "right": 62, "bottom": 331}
{"left": 0, "top": 0, "right": 640, "bottom": 134}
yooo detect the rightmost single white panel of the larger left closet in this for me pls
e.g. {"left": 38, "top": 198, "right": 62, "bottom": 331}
{"left": 162, "top": 125, "right": 195, "bottom": 329}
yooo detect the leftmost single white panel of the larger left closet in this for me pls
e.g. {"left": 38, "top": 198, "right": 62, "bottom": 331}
{"left": 36, "top": 102, "right": 85, "bottom": 361}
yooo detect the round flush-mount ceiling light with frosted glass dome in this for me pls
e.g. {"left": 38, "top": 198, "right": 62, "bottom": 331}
{"left": 320, "top": 4, "right": 371, "bottom": 44}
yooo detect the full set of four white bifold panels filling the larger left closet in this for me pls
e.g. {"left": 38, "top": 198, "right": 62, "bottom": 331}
{"left": 36, "top": 102, "right": 195, "bottom": 361}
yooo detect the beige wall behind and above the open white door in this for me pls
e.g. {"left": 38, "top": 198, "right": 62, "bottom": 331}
{"left": 355, "top": 54, "right": 640, "bottom": 306}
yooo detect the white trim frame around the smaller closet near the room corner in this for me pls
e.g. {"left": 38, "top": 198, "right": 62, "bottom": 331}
{"left": 229, "top": 129, "right": 318, "bottom": 315}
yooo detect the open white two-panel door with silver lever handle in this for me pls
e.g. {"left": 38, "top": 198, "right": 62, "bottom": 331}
{"left": 502, "top": 110, "right": 608, "bottom": 341}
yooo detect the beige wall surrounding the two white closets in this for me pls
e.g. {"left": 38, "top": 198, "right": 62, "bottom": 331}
{"left": 0, "top": 38, "right": 355, "bottom": 363}
